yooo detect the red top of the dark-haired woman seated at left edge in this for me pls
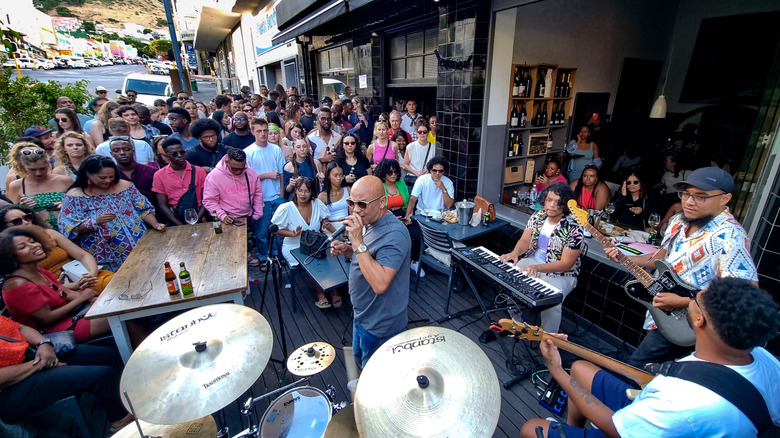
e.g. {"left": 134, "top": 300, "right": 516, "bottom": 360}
{"left": 3, "top": 268, "right": 73, "bottom": 332}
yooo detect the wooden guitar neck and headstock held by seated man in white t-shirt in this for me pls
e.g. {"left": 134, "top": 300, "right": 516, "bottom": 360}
{"left": 490, "top": 318, "right": 655, "bottom": 388}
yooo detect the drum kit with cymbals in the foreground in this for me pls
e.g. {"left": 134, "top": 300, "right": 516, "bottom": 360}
{"left": 115, "top": 304, "right": 501, "bottom": 438}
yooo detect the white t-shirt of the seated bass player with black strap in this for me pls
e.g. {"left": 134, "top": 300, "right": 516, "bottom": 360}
{"left": 612, "top": 348, "right": 780, "bottom": 438}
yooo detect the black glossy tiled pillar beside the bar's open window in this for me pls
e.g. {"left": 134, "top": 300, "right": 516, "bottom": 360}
{"left": 436, "top": 1, "right": 490, "bottom": 199}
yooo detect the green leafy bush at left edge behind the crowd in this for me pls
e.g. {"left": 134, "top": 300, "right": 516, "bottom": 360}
{"left": 0, "top": 59, "right": 92, "bottom": 157}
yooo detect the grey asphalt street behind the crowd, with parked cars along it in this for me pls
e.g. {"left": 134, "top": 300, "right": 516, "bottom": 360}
{"left": 22, "top": 64, "right": 217, "bottom": 103}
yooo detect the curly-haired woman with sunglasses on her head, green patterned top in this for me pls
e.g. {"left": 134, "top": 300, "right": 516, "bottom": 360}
{"left": 6, "top": 142, "right": 73, "bottom": 228}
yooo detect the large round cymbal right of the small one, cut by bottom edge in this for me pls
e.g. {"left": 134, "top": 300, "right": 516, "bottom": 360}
{"left": 355, "top": 327, "right": 501, "bottom": 437}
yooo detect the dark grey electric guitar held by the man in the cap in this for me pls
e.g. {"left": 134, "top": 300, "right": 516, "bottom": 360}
{"left": 566, "top": 199, "right": 699, "bottom": 347}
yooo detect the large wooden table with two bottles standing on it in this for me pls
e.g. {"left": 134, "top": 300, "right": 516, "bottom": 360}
{"left": 86, "top": 223, "right": 248, "bottom": 362}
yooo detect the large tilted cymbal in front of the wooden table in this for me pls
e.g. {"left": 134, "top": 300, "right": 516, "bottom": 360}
{"left": 120, "top": 304, "right": 273, "bottom": 424}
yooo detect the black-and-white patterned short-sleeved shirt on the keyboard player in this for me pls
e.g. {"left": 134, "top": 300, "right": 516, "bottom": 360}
{"left": 525, "top": 210, "right": 583, "bottom": 277}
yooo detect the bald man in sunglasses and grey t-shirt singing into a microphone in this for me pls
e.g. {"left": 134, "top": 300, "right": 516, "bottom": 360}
{"left": 331, "top": 176, "right": 412, "bottom": 366}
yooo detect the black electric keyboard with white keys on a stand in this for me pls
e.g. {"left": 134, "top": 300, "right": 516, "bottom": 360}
{"left": 451, "top": 246, "right": 563, "bottom": 308}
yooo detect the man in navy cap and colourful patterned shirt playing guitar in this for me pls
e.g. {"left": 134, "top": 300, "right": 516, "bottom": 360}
{"left": 604, "top": 167, "right": 758, "bottom": 368}
